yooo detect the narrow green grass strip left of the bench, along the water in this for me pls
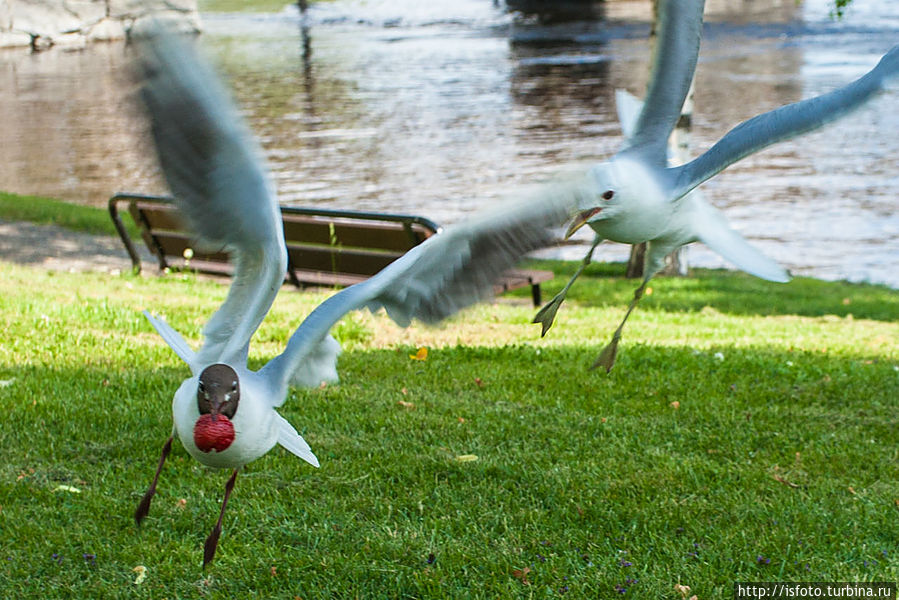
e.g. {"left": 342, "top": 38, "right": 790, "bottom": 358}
{"left": 0, "top": 192, "right": 140, "bottom": 239}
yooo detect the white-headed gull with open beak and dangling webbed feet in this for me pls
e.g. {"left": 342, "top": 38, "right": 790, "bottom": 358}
{"left": 533, "top": 0, "right": 899, "bottom": 372}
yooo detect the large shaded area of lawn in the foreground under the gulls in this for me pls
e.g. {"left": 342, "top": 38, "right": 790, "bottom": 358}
{"left": 0, "top": 345, "right": 899, "bottom": 598}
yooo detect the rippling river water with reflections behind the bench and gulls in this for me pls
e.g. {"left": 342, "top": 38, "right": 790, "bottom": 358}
{"left": 0, "top": 0, "right": 899, "bottom": 286}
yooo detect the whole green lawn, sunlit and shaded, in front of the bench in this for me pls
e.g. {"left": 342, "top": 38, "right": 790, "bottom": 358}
{"left": 0, "top": 255, "right": 899, "bottom": 599}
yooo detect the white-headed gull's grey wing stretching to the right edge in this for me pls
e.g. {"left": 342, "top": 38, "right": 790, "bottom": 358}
{"left": 673, "top": 46, "right": 899, "bottom": 197}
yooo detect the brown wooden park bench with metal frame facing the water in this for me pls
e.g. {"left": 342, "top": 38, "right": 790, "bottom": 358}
{"left": 109, "top": 193, "right": 553, "bottom": 306}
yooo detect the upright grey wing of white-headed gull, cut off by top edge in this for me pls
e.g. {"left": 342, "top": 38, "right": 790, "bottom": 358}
{"left": 621, "top": 0, "right": 705, "bottom": 166}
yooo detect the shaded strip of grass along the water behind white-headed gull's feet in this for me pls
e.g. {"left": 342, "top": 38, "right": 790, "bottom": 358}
{"left": 529, "top": 261, "right": 899, "bottom": 321}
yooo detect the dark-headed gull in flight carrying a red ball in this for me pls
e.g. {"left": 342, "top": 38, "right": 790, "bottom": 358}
{"left": 134, "top": 23, "right": 580, "bottom": 568}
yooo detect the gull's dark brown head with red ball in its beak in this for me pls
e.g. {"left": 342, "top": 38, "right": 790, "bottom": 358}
{"left": 194, "top": 364, "right": 240, "bottom": 452}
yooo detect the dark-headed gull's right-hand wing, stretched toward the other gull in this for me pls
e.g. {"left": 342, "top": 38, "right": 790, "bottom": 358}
{"left": 260, "top": 180, "right": 589, "bottom": 398}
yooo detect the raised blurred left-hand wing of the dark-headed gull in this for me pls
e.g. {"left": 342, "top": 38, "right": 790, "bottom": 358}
{"left": 137, "top": 25, "right": 287, "bottom": 364}
